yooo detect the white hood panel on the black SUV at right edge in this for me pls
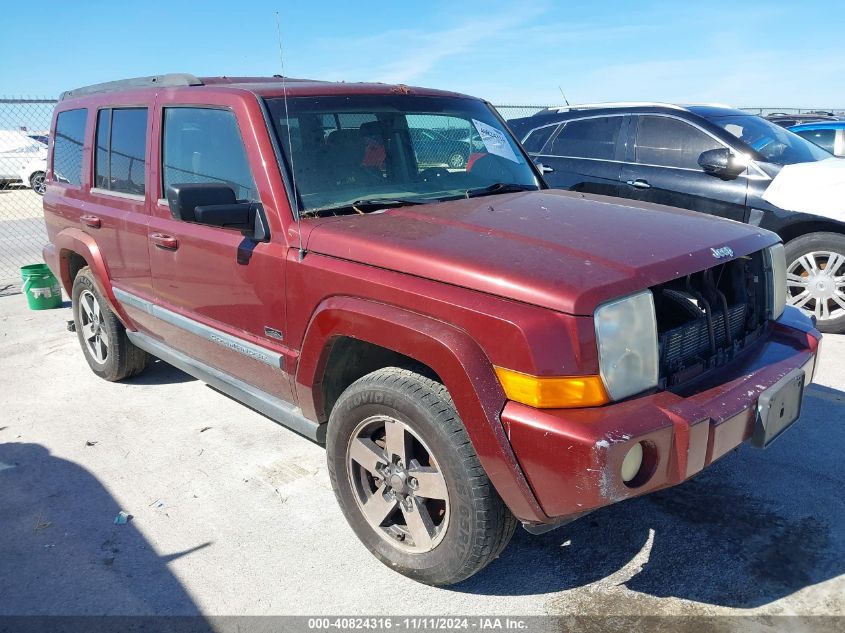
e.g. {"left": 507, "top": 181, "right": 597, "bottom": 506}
{"left": 763, "top": 158, "right": 845, "bottom": 222}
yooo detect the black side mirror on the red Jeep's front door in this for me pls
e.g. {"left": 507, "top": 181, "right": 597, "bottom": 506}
{"left": 167, "top": 183, "right": 270, "bottom": 242}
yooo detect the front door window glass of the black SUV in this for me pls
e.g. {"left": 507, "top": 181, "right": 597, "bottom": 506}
{"left": 634, "top": 116, "right": 724, "bottom": 169}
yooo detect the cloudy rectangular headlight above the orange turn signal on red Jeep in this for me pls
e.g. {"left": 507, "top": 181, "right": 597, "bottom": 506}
{"left": 595, "top": 290, "right": 658, "bottom": 400}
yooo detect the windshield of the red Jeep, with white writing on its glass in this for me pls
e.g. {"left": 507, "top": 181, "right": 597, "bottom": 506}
{"left": 267, "top": 95, "right": 539, "bottom": 213}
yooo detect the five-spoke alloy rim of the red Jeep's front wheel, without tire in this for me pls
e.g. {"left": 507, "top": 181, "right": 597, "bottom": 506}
{"left": 346, "top": 415, "right": 449, "bottom": 553}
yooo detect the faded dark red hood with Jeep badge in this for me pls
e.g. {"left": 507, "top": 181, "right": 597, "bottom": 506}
{"left": 303, "top": 190, "right": 777, "bottom": 315}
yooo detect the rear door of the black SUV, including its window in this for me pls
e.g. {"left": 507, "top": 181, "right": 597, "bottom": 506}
{"left": 526, "top": 114, "right": 630, "bottom": 196}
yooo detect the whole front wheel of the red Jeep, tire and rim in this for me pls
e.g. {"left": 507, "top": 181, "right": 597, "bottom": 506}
{"left": 326, "top": 367, "right": 517, "bottom": 585}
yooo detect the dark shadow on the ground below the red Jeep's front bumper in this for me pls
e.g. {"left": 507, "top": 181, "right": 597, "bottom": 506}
{"left": 452, "top": 385, "right": 845, "bottom": 608}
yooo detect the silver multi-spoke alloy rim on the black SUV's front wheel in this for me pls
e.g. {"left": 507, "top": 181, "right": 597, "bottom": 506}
{"left": 786, "top": 251, "right": 845, "bottom": 321}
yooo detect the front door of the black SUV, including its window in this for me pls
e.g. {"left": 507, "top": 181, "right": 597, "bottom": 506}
{"left": 620, "top": 114, "right": 748, "bottom": 222}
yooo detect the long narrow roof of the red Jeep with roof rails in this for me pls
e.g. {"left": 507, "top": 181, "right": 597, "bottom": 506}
{"left": 60, "top": 73, "right": 466, "bottom": 100}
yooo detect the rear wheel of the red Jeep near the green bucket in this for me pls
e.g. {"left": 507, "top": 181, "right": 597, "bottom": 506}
{"left": 71, "top": 266, "right": 149, "bottom": 382}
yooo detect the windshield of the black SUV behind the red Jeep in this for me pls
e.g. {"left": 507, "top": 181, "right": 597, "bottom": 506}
{"left": 710, "top": 114, "right": 832, "bottom": 165}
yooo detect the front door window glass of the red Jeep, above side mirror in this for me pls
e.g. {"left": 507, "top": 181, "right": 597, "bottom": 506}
{"left": 161, "top": 108, "right": 258, "bottom": 201}
